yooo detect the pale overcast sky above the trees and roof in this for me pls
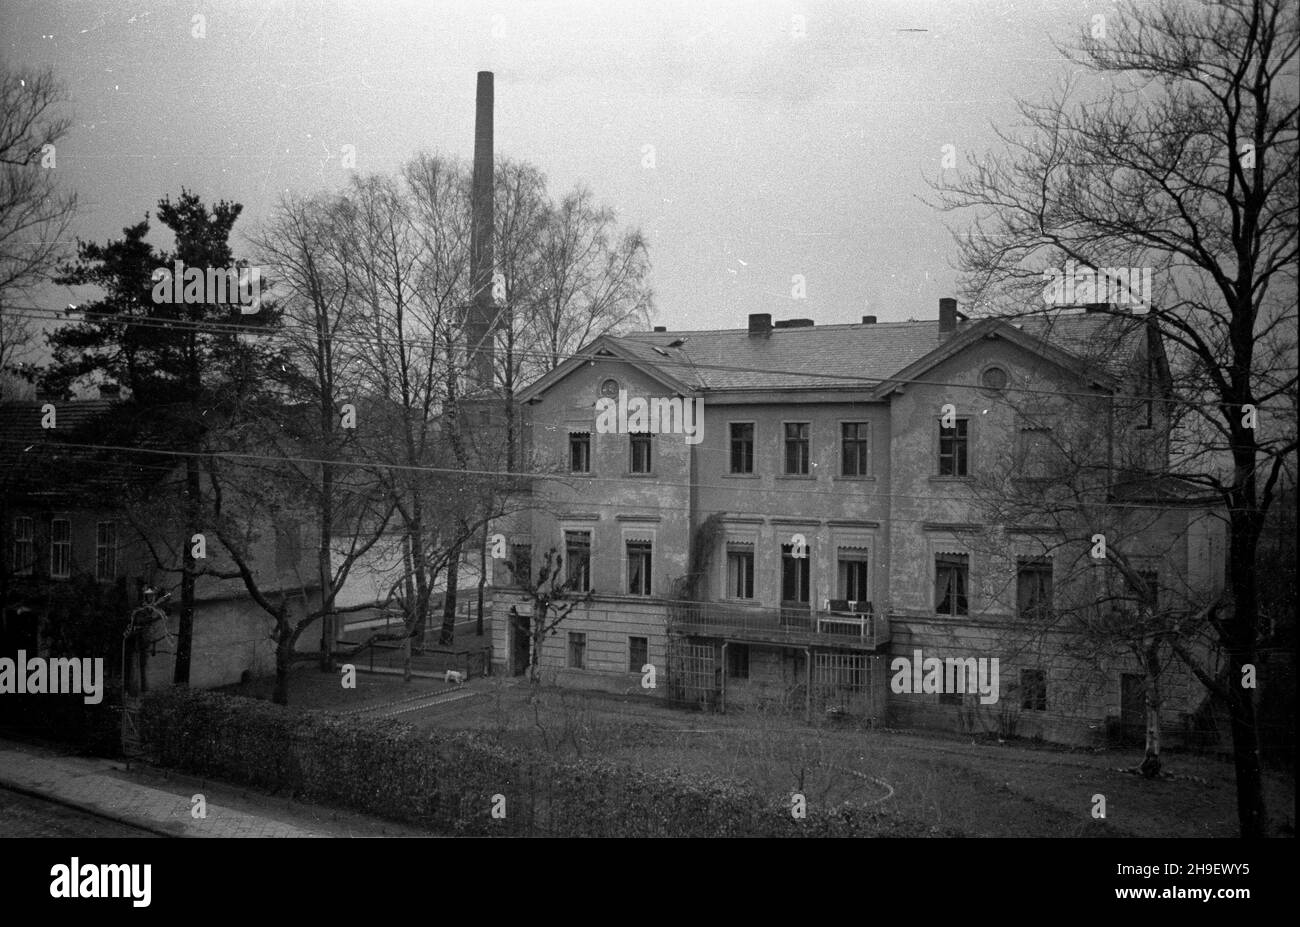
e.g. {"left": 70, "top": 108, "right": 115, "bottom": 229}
{"left": 0, "top": 0, "right": 1115, "bottom": 329}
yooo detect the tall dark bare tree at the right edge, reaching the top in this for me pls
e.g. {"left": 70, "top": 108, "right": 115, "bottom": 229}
{"left": 940, "top": 0, "right": 1300, "bottom": 836}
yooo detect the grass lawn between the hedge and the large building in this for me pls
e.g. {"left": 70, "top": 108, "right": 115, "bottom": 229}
{"left": 234, "top": 667, "right": 1295, "bottom": 837}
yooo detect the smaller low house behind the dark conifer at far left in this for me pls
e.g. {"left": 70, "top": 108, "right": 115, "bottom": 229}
{"left": 0, "top": 394, "right": 312, "bottom": 686}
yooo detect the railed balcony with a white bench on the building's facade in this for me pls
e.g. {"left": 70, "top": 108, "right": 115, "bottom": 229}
{"left": 668, "top": 599, "right": 889, "bottom": 650}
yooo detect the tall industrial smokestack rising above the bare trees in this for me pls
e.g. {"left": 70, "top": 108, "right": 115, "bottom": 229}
{"left": 465, "top": 70, "right": 497, "bottom": 390}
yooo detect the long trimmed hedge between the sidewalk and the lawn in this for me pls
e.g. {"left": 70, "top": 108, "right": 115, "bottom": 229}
{"left": 142, "top": 689, "right": 932, "bottom": 837}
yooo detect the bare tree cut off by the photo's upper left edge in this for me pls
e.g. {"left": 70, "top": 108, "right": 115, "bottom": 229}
{"left": 0, "top": 69, "right": 77, "bottom": 389}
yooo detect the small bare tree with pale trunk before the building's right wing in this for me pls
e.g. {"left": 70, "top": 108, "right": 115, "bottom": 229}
{"left": 972, "top": 343, "right": 1223, "bottom": 777}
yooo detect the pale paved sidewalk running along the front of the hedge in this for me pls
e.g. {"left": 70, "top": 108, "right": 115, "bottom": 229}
{"left": 0, "top": 740, "right": 432, "bottom": 837}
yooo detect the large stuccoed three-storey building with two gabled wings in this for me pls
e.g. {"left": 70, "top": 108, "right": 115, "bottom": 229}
{"left": 493, "top": 299, "right": 1223, "bottom": 741}
